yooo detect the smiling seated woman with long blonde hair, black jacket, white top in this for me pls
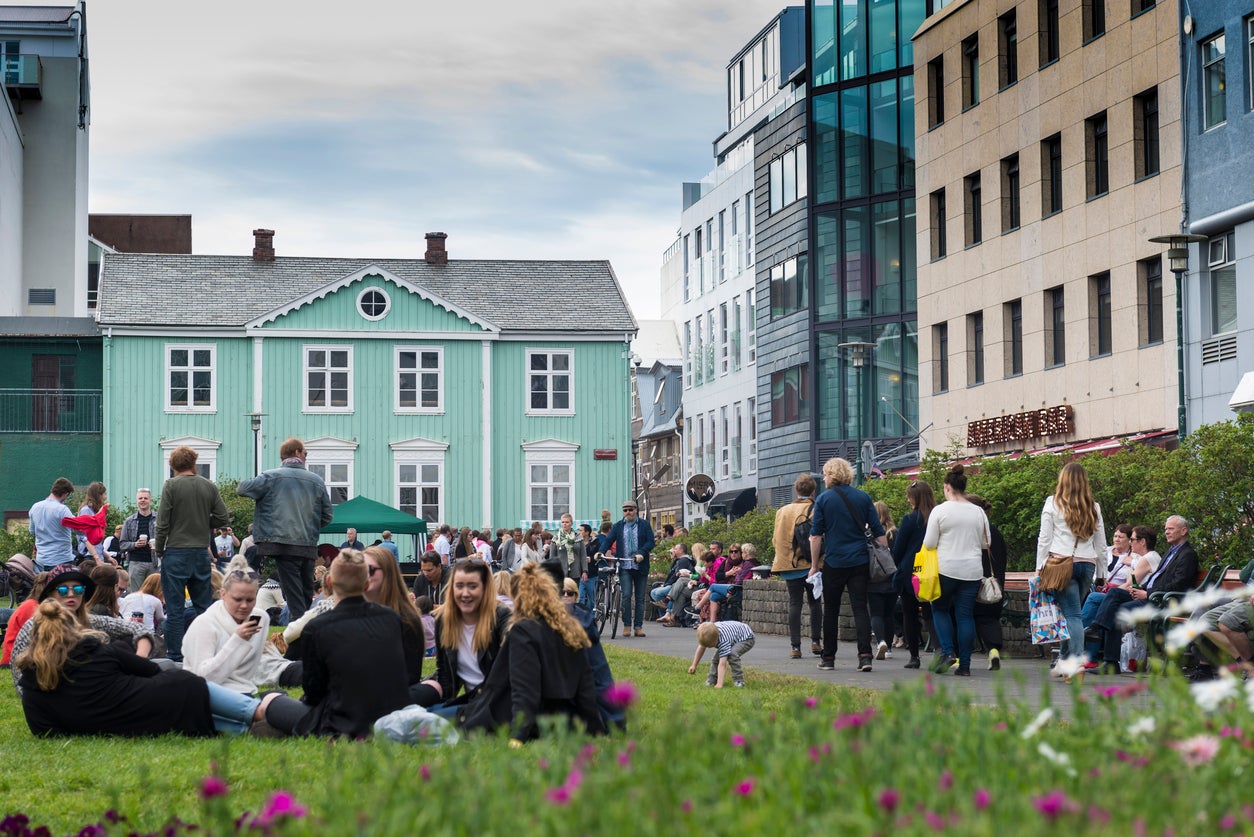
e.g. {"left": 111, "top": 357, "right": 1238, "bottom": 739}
{"left": 410, "top": 558, "right": 510, "bottom": 715}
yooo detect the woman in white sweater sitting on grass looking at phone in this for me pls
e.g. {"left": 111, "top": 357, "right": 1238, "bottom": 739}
{"left": 183, "top": 555, "right": 302, "bottom": 694}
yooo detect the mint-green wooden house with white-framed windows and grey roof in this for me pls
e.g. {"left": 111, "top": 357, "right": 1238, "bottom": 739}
{"left": 99, "top": 231, "right": 636, "bottom": 539}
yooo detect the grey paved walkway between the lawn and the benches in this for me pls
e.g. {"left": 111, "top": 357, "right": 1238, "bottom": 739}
{"left": 602, "top": 622, "right": 1152, "bottom": 717}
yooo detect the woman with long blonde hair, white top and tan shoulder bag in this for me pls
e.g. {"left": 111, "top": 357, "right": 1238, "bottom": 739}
{"left": 1036, "top": 462, "right": 1106, "bottom": 656}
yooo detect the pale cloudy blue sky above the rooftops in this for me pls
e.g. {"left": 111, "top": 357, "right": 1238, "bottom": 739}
{"left": 63, "top": 0, "right": 785, "bottom": 319}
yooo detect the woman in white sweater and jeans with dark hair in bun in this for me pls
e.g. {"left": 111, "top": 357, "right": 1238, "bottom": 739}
{"left": 923, "top": 466, "right": 992, "bottom": 678}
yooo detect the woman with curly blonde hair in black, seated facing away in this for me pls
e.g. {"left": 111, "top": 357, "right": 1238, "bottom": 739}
{"left": 461, "top": 565, "right": 606, "bottom": 742}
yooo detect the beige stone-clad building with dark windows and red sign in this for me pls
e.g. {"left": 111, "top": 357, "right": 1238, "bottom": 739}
{"left": 914, "top": 0, "right": 1181, "bottom": 453}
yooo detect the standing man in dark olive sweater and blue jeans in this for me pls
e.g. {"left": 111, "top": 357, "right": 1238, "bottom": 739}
{"left": 154, "top": 444, "right": 231, "bottom": 663}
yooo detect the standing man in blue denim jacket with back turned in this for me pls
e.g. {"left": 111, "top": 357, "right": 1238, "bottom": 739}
{"left": 236, "top": 438, "right": 336, "bottom": 622}
